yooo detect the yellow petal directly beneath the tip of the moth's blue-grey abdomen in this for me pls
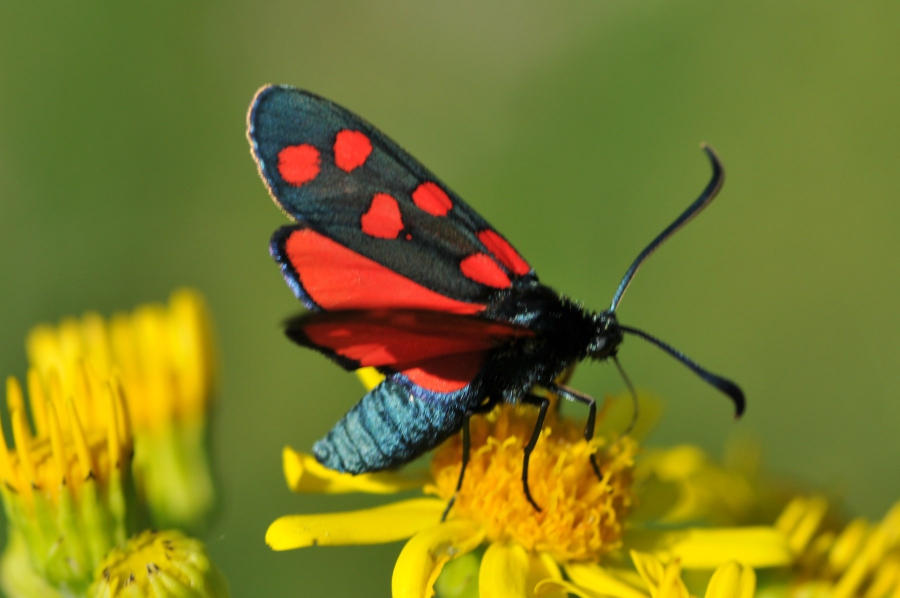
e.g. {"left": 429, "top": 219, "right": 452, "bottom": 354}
{"left": 282, "top": 446, "right": 431, "bottom": 494}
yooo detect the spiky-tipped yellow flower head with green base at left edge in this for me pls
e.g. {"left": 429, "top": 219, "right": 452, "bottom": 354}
{"left": 0, "top": 366, "right": 134, "bottom": 596}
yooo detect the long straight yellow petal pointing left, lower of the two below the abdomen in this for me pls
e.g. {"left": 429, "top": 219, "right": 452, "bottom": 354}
{"left": 266, "top": 498, "right": 447, "bottom": 550}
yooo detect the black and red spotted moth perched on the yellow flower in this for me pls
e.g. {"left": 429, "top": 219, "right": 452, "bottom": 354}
{"left": 248, "top": 86, "right": 744, "bottom": 508}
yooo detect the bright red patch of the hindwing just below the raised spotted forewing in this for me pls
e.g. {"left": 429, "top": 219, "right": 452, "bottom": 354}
{"left": 285, "top": 228, "right": 486, "bottom": 314}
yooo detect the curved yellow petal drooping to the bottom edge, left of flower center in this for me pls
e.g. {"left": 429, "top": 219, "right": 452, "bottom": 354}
{"left": 391, "top": 520, "right": 485, "bottom": 598}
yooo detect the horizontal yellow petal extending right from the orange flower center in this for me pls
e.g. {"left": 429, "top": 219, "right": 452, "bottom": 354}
{"left": 625, "top": 526, "right": 793, "bottom": 569}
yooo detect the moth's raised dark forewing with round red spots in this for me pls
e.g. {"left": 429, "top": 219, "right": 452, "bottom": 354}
{"left": 248, "top": 86, "right": 535, "bottom": 313}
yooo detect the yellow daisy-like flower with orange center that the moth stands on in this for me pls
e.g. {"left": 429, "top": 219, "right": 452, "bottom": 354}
{"left": 266, "top": 370, "right": 791, "bottom": 598}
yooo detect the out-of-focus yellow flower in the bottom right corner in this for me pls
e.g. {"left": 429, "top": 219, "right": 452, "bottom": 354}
{"left": 770, "top": 497, "right": 900, "bottom": 598}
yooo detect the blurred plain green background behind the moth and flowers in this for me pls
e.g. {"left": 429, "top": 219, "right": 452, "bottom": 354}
{"left": 0, "top": 0, "right": 900, "bottom": 596}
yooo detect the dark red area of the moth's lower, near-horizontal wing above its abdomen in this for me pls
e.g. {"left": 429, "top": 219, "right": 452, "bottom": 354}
{"left": 300, "top": 311, "right": 533, "bottom": 370}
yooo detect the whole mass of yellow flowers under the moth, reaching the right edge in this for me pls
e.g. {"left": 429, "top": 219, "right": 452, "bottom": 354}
{"left": 266, "top": 371, "right": 900, "bottom": 598}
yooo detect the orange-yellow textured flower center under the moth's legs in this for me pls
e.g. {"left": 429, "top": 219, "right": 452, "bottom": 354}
{"left": 428, "top": 405, "right": 637, "bottom": 562}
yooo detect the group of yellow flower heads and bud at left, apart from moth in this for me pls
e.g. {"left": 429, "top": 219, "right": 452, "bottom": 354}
{"left": 0, "top": 291, "right": 228, "bottom": 598}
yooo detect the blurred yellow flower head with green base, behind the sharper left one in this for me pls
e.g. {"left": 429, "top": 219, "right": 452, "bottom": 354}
{"left": 26, "top": 290, "right": 215, "bottom": 528}
